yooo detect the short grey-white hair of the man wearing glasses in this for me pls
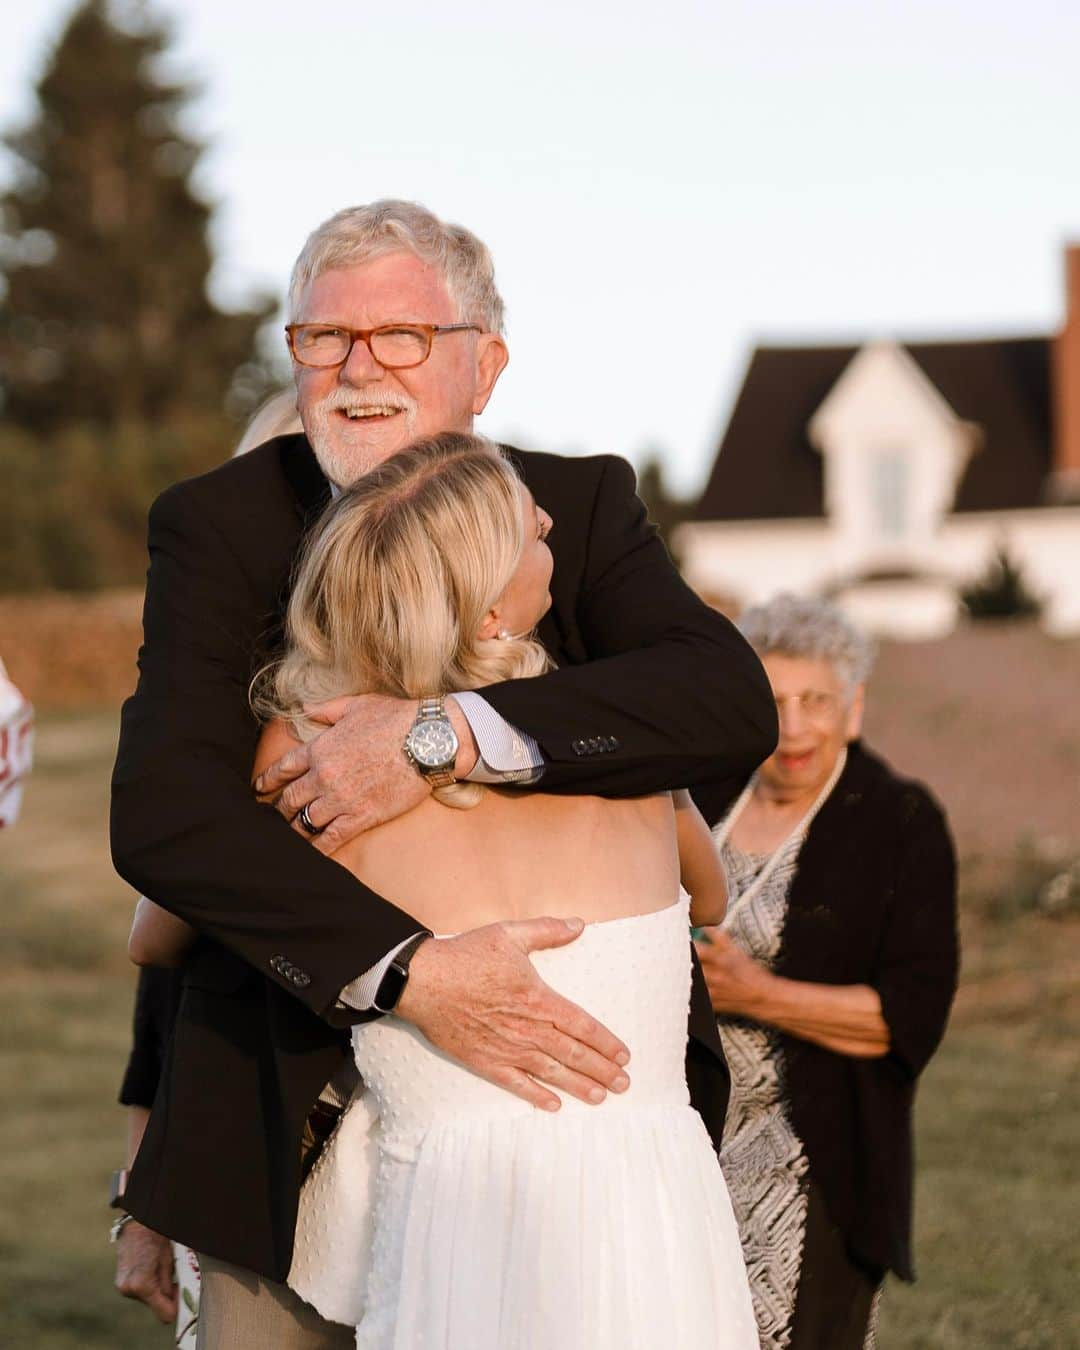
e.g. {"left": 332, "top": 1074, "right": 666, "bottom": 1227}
{"left": 289, "top": 198, "right": 505, "bottom": 333}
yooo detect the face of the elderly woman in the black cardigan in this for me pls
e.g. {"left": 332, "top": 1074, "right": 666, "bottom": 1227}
{"left": 760, "top": 652, "right": 864, "bottom": 792}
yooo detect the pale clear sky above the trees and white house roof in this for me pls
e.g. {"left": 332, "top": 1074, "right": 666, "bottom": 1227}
{"left": 0, "top": 0, "right": 1080, "bottom": 491}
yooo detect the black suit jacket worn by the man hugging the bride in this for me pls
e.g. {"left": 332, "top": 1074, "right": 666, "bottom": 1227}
{"left": 112, "top": 436, "right": 775, "bottom": 1278}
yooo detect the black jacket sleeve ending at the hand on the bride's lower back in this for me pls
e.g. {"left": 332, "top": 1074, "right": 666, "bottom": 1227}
{"left": 111, "top": 485, "right": 417, "bottom": 1021}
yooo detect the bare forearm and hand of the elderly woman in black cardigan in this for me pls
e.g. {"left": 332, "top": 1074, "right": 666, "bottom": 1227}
{"left": 698, "top": 932, "right": 891, "bottom": 1058}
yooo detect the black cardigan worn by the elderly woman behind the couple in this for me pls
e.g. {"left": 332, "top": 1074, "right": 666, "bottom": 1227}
{"left": 695, "top": 741, "right": 959, "bottom": 1280}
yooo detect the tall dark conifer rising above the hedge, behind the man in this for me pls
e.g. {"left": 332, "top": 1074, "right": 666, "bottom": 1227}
{"left": 0, "top": 0, "right": 273, "bottom": 432}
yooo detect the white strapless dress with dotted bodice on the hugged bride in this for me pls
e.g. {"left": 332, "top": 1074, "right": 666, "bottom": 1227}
{"left": 290, "top": 899, "right": 757, "bottom": 1350}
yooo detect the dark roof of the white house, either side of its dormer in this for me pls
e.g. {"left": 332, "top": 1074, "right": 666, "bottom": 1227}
{"left": 695, "top": 338, "right": 1050, "bottom": 520}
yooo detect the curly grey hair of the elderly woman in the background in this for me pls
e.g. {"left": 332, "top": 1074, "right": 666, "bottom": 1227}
{"left": 737, "top": 594, "right": 878, "bottom": 694}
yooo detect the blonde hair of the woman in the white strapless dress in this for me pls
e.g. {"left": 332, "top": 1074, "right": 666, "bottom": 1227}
{"left": 252, "top": 432, "right": 551, "bottom": 806}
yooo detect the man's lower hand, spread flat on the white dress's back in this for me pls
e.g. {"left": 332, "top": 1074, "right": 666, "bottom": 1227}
{"left": 396, "top": 918, "right": 630, "bottom": 1111}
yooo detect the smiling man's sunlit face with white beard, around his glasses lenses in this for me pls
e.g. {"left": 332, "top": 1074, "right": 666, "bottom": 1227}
{"left": 293, "top": 252, "right": 508, "bottom": 487}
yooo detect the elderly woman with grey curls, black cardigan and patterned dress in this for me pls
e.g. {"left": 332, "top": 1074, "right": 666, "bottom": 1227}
{"left": 698, "top": 595, "right": 957, "bottom": 1350}
